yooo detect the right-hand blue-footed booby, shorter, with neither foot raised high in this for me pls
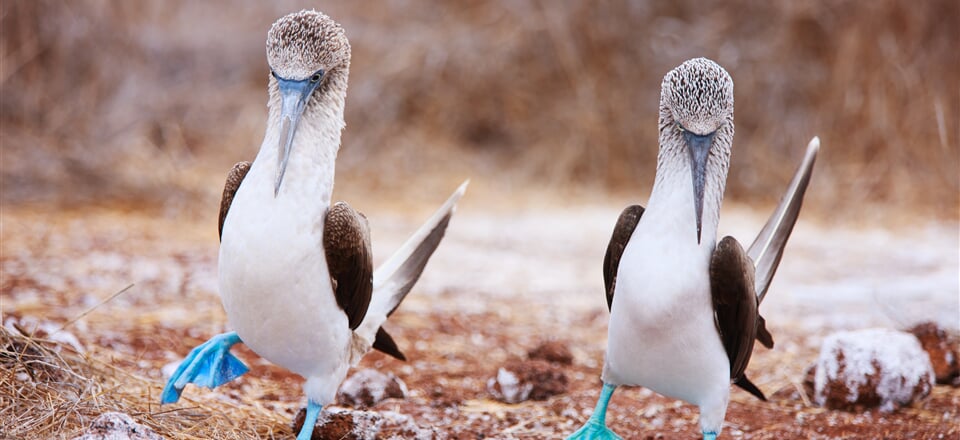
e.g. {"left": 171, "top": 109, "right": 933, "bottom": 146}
{"left": 569, "top": 58, "right": 820, "bottom": 439}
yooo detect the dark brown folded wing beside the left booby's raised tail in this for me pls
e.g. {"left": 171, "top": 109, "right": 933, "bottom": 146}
{"left": 323, "top": 202, "right": 373, "bottom": 330}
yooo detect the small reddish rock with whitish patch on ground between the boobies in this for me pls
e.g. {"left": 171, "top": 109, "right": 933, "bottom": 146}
{"left": 487, "top": 359, "right": 567, "bottom": 403}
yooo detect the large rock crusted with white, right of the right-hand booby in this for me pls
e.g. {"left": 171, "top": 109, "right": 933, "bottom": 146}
{"left": 814, "top": 329, "right": 934, "bottom": 411}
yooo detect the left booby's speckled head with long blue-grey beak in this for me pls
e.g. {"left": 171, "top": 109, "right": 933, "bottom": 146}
{"left": 267, "top": 10, "right": 350, "bottom": 195}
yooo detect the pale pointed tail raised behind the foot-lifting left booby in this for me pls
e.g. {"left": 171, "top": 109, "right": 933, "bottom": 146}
{"left": 357, "top": 180, "right": 470, "bottom": 341}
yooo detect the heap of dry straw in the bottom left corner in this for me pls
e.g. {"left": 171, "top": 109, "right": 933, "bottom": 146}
{"left": 0, "top": 325, "right": 291, "bottom": 439}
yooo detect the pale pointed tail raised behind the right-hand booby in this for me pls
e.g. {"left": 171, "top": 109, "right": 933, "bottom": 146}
{"left": 747, "top": 136, "right": 820, "bottom": 302}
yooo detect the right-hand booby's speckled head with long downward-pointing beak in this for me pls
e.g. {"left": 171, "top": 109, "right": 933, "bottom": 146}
{"left": 659, "top": 58, "right": 733, "bottom": 243}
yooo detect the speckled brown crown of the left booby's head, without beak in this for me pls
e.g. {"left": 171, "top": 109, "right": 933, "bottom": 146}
{"left": 267, "top": 10, "right": 350, "bottom": 80}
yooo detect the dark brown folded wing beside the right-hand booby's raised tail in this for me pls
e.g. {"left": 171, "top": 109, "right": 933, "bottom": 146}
{"left": 710, "top": 237, "right": 772, "bottom": 400}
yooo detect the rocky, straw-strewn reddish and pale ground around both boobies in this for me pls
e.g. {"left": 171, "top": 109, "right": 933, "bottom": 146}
{"left": 0, "top": 198, "right": 960, "bottom": 439}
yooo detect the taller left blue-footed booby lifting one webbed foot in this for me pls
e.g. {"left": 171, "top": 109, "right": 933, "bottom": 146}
{"left": 161, "top": 11, "right": 467, "bottom": 440}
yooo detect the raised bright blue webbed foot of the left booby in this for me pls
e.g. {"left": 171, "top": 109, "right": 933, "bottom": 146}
{"left": 160, "top": 332, "right": 249, "bottom": 403}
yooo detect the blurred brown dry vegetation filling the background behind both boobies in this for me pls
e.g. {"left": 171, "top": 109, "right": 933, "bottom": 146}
{"left": 0, "top": 0, "right": 960, "bottom": 218}
